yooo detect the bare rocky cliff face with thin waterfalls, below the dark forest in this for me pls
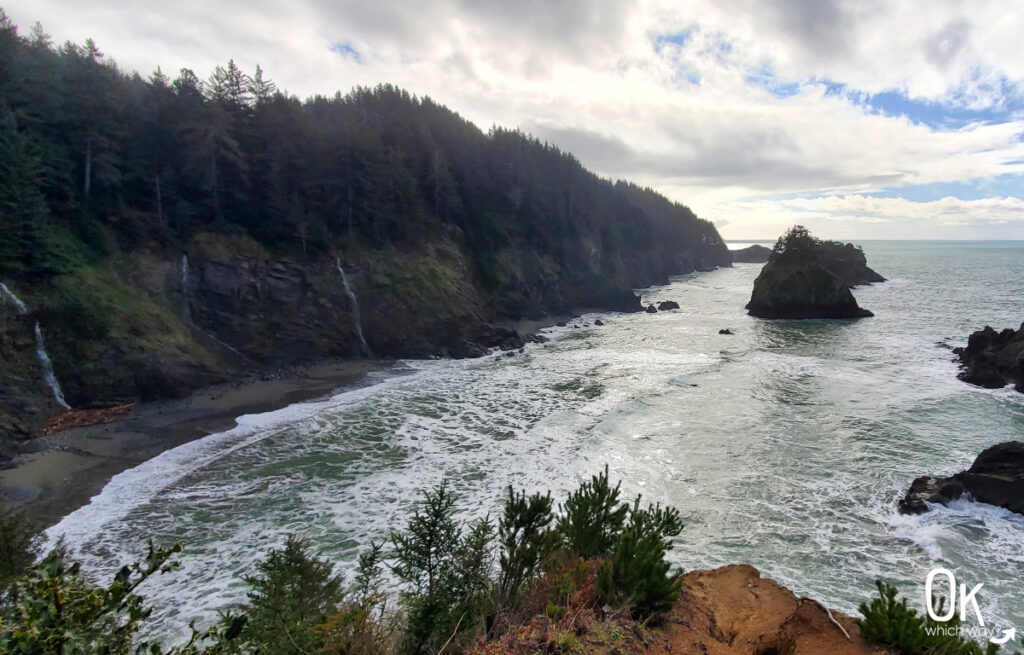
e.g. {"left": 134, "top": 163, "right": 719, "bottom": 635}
{"left": 0, "top": 216, "right": 729, "bottom": 443}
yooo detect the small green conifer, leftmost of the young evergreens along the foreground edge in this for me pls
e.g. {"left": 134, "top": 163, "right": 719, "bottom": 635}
{"left": 244, "top": 535, "right": 345, "bottom": 655}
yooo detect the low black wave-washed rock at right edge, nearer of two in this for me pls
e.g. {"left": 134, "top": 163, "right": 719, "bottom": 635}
{"left": 899, "top": 441, "right": 1024, "bottom": 514}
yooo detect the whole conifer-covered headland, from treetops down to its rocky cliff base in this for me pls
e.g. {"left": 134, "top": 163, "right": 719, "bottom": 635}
{"left": 0, "top": 13, "right": 729, "bottom": 446}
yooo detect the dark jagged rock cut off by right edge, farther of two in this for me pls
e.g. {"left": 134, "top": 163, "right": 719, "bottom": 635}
{"left": 953, "top": 323, "right": 1024, "bottom": 393}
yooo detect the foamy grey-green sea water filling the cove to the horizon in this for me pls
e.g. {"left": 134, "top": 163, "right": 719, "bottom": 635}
{"left": 51, "top": 242, "right": 1024, "bottom": 634}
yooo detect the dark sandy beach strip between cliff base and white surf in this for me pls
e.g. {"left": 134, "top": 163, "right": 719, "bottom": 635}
{"left": 0, "top": 360, "right": 394, "bottom": 527}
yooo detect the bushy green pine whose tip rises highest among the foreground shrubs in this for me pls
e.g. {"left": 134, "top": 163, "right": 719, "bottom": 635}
{"left": 558, "top": 466, "right": 629, "bottom": 559}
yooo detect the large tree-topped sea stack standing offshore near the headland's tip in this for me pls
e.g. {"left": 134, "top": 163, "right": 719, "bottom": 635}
{"left": 746, "top": 225, "right": 885, "bottom": 318}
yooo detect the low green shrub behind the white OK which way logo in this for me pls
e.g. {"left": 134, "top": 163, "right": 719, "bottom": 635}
{"left": 857, "top": 580, "right": 998, "bottom": 655}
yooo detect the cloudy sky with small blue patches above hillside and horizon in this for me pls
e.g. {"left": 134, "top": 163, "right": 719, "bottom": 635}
{"left": 8, "top": 0, "right": 1024, "bottom": 239}
